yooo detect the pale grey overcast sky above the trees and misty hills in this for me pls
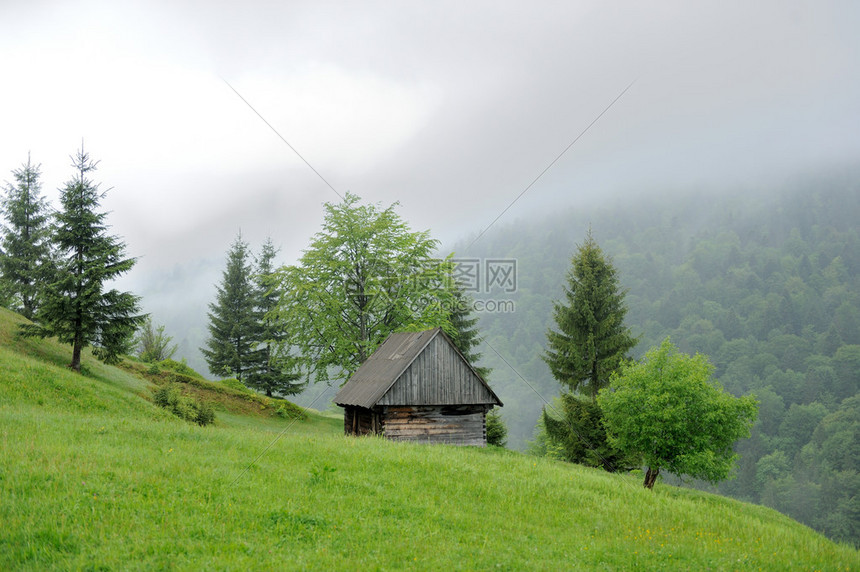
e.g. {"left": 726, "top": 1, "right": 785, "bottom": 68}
{"left": 0, "top": 0, "right": 860, "bottom": 370}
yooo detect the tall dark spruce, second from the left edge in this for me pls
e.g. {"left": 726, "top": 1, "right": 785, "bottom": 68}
{"left": 22, "top": 146, "right": 145, "bottom": 371}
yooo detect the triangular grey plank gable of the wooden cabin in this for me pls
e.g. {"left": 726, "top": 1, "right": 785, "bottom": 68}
{"left": 377, "top": 336, "right": 496, "bottom": 405}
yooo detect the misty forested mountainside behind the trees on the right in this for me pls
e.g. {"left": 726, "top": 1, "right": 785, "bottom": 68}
{"left": 466, "top": 173, "right": 860, "bottom": 543}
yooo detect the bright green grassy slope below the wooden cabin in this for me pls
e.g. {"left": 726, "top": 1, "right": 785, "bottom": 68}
{"left": 0, "top": 310, "right": 860, "bottom": 570}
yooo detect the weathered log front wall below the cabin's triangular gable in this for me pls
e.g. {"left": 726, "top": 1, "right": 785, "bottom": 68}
{"left": 382, "top": 405, "right": 487, "bottom": 447}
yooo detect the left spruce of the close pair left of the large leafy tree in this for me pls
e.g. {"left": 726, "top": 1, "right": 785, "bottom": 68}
{"left": 200, "top": 233, "right": 259, "bottom": 381}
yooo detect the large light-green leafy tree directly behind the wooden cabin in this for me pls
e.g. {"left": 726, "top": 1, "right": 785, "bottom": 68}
{"left": 277, "top": 193, "right": 451, "bottom": 381}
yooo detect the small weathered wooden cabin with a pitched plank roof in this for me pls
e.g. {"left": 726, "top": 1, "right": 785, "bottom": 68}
{"left": 334, "top": 328, "right": 502, "bottom": 447}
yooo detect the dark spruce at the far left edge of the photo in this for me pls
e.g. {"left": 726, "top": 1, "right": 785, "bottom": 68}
{"left": 0, "top": 155, "right": 51, "bottom": 320}
